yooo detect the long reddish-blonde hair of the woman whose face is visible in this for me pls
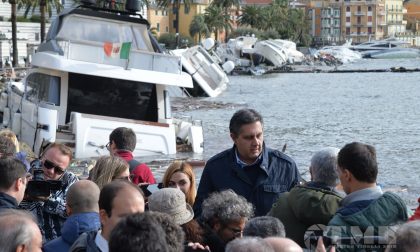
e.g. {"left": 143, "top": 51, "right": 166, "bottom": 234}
{"left": 162, "top": 161, "right": 197, "bottom": 206}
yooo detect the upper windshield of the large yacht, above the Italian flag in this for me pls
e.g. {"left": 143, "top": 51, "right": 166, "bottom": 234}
{"left": 56, "top": 14, "right": 153, "bottom": 51}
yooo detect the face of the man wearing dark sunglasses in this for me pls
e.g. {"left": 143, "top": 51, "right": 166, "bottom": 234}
{"left": 41, "top": 148, "right": 70, "bottom": 180}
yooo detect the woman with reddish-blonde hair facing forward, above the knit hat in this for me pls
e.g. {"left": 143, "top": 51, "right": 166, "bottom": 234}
{"left": 162, "top": 161, "right": 197, "bottom": 206}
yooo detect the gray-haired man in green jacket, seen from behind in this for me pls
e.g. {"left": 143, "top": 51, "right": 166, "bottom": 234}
{"left": 268, "top": 147, "right": 342, "bottom": 247}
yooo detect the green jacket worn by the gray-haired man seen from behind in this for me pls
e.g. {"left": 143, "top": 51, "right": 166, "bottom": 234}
{"left": 268, "top": 185, "right": 342, "bottom": 248}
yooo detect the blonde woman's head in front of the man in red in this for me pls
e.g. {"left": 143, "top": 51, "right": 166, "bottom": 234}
{"left": 89, "top": 156, "right": 131, "bottom": 190}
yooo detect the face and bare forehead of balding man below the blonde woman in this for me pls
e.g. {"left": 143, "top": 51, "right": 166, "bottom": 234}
{"left": 99, "top": 188, "right": 144, "bottom": 241}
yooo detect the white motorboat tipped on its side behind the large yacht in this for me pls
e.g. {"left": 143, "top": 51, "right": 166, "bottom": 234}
{"left": 172, "top": 45, "right": 233, "bottom": 97}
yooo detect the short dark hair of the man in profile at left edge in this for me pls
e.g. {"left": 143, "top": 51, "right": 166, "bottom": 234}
{"left": 0, "top": 158, "right": 26, "bottom": 191}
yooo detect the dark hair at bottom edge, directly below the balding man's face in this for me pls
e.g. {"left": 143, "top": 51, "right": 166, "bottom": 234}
{"left": 109, "top": 212, "right": 169, "bottom": 252}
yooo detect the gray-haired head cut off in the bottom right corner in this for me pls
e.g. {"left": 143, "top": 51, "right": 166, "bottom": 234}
{"left": 385, "top": 221, "right": 420, "bottom": 252}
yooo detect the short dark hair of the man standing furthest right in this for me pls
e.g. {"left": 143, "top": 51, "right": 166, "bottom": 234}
{"left": 337, "top": 142, "right": 378, "bottom": 183}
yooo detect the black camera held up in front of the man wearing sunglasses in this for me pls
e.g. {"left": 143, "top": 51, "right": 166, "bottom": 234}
{"left": 25, "top": 159, "right": 62, "bottom": 198}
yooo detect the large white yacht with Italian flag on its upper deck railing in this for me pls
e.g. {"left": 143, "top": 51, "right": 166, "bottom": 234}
{"left": 0, "top": 1, "right": 203, "bottom": 158}
